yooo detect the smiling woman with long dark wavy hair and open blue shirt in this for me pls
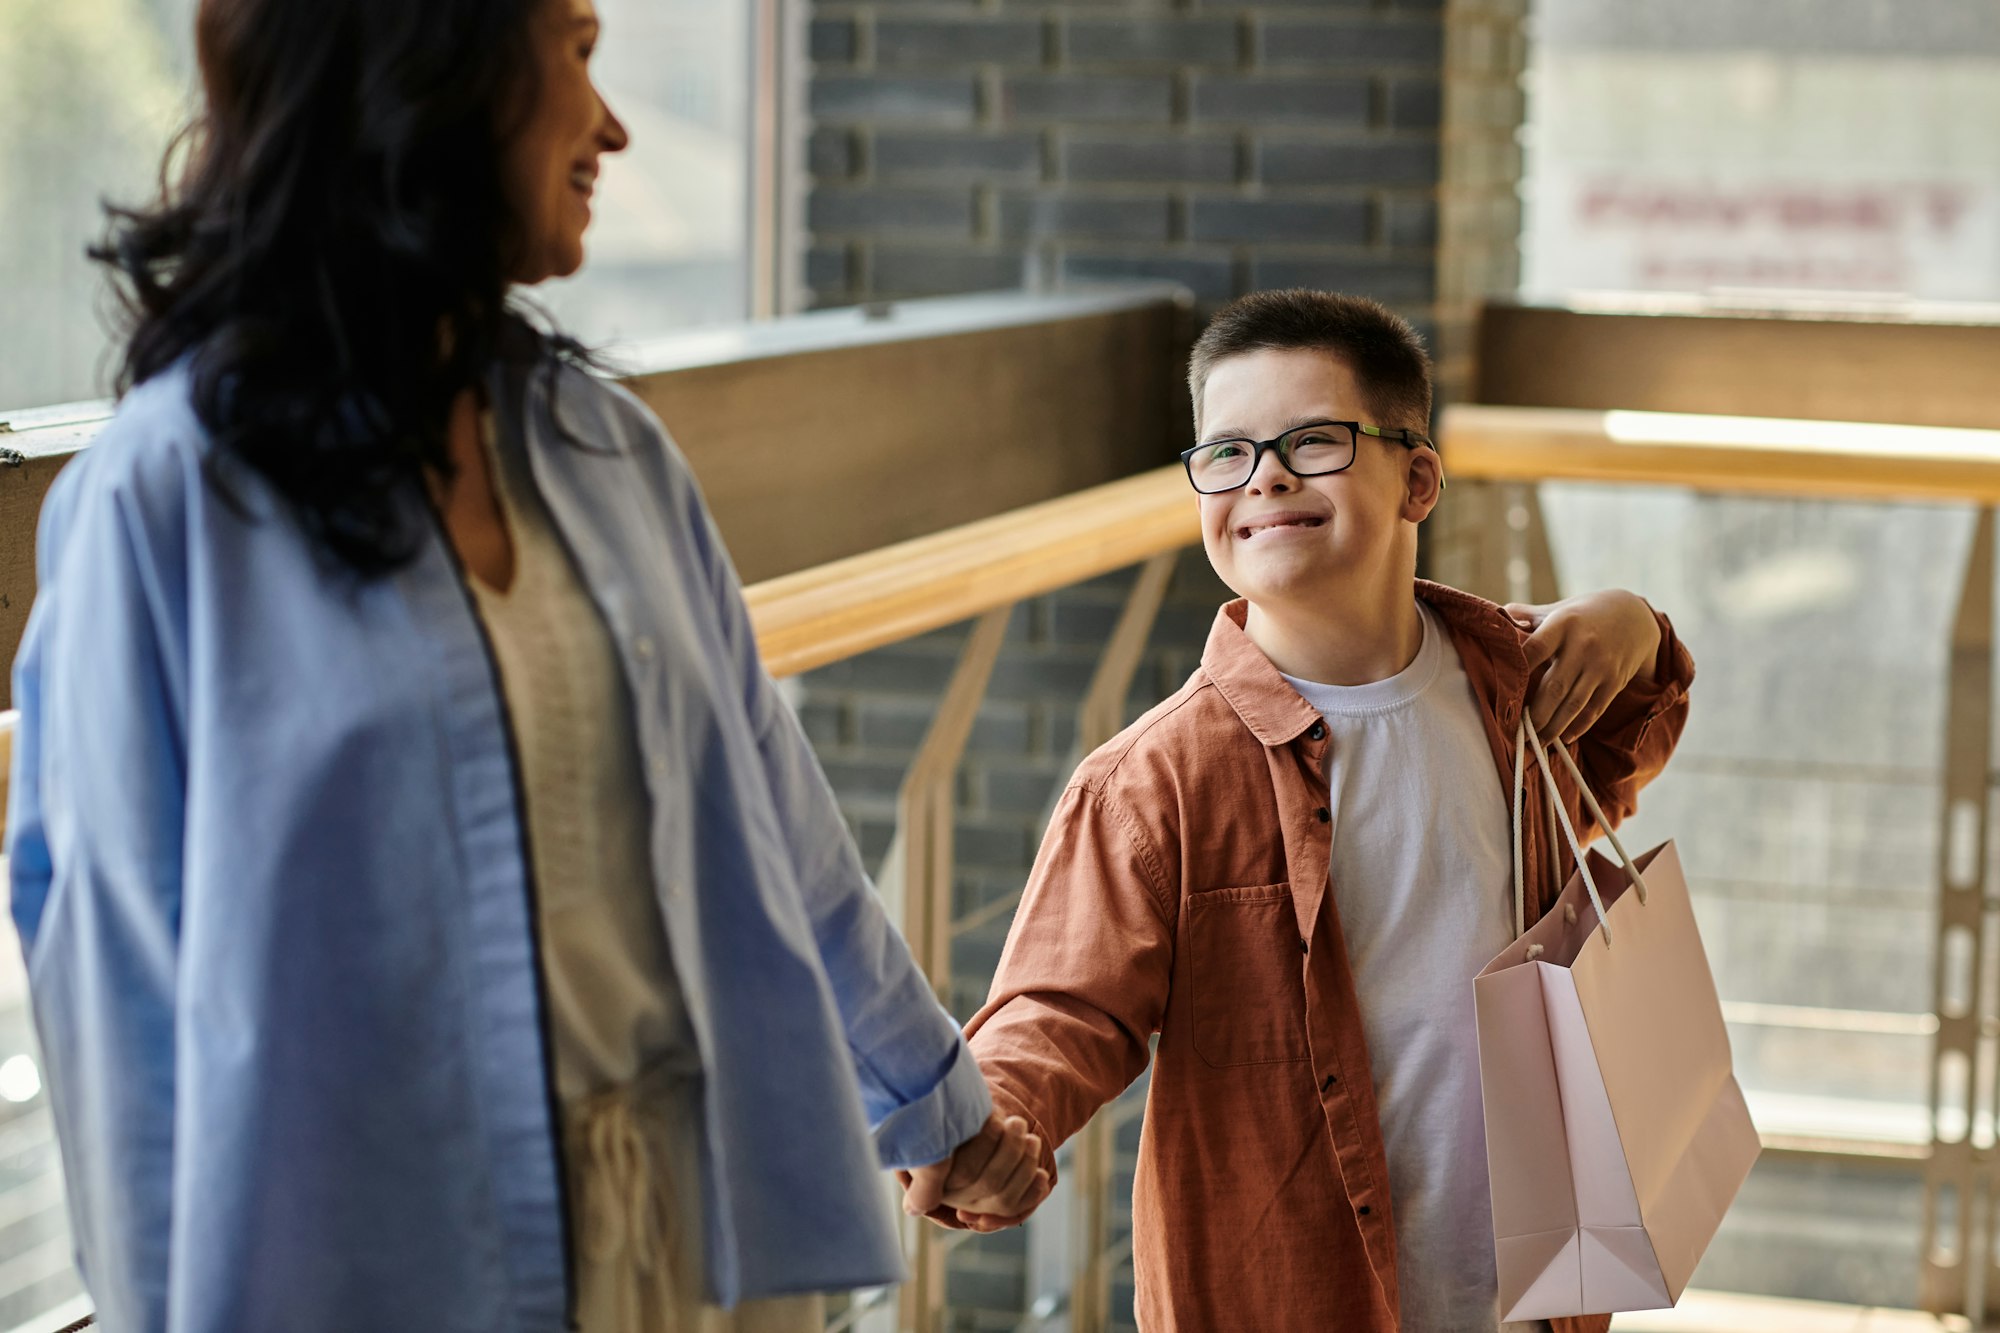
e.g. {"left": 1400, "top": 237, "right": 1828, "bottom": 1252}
{"left": 8, "top": 0, "right": 1048, "bottom": 1333}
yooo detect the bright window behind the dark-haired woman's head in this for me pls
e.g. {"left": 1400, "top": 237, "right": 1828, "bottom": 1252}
{"left": 0, "top": 0, "right": 774, "bottom": 408}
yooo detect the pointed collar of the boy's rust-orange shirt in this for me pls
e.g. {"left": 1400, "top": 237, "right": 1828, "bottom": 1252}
{"left": 1202, "top": 578, "right": 1528, "bottom": 747}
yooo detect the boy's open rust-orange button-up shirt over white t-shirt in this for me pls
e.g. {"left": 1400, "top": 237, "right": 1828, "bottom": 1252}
{"left": 966, "top": 582, "right": 1694, "bottom": 1333}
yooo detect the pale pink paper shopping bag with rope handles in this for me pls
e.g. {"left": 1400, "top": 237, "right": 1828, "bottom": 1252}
{"left": 1472, "top": 721, "right": 1758, "bottom": 1319}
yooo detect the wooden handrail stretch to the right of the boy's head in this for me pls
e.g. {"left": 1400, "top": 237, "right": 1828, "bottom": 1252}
{"left": 1438, "top": 404, "right": 2000, "bottom": 504}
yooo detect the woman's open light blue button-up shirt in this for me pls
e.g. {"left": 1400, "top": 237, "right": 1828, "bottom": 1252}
{"left": 8, "top": 352, "right": 990, "bottom": 1333}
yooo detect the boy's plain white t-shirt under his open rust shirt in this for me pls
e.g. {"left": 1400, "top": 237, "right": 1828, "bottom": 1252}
{"left": 1286, "top": 602, "right": 1542, "bottom": 1333}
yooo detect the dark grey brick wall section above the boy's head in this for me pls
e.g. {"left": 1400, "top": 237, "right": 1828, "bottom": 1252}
{"left": 808, "top": 0, "right": 1472, "bottom": 342}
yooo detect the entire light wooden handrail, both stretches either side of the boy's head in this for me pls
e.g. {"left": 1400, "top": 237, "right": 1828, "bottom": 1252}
{"left": 0, "top": 404, "right": 2000, "bottom": 831}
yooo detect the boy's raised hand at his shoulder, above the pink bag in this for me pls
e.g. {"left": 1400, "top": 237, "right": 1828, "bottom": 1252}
{"left": 1506, "top": 588, "right": 1660, "bottom": 745}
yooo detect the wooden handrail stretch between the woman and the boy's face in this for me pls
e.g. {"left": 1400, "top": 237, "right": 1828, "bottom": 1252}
{"left": 744, "top": 466, "right": 1202, "bottom": 677}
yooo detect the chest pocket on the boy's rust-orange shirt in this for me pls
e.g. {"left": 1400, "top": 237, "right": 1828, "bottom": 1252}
{"left": 1182, "top": 885, "right": 1308, "bottom": 1067}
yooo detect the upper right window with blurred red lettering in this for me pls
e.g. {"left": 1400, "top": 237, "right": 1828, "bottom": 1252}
{"left": 1522, "top": 0, "right": 2000, "bottom": 300}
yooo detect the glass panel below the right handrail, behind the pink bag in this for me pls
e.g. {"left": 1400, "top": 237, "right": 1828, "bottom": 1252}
{"left": 1540, "top": 484, "right": 1960, "bottom": 1305}
